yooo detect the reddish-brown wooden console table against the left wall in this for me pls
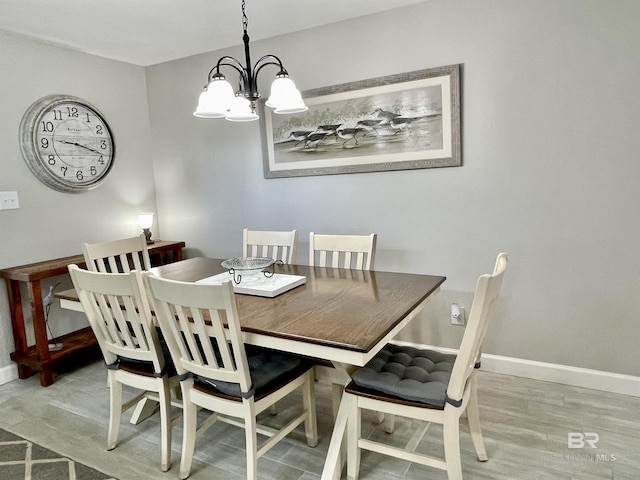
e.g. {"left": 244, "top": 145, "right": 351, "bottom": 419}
{"left": 0, "top": 240, "right": 185, "bottom": 387}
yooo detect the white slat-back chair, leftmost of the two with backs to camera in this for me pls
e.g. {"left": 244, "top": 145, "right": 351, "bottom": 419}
{"left": 68, "top": 264, "right": 181, "bottom": 471}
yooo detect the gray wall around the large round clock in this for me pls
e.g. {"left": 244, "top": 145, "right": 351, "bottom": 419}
{"left": 0, "top": 34, "right": 155, "bottom": 383}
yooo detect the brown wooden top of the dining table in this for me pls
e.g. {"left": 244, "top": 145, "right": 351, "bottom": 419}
{"left": 152, "top": 257, "right": 446, "bottom": 352}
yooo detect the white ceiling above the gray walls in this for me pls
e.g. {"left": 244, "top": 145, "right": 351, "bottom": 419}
{"left": 0, "top": 0, "right": 427, "bottom": 66}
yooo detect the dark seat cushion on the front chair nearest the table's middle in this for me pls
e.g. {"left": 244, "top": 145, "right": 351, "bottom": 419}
{"left": 194, "top": 345, "right": 311, "bottom": 398}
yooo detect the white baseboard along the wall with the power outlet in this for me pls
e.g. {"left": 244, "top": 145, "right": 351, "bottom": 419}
{"left": 394, "top": 341, "right": 640, "bottom": 397}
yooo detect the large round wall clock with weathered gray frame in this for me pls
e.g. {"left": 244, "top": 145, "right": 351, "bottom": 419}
{"left": 19, "top": 95, "right": 115, "bottom": 192}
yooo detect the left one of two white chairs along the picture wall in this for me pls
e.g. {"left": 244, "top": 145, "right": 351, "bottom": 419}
{"left": 242, "top": 228, "right": 298, "bottom": 264}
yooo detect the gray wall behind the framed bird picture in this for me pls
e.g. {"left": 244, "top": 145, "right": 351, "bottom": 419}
{"left": 147, "top": 0, "right": 640, "bottom": 375}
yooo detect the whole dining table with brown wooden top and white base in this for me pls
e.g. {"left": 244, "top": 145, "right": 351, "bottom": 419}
{"left": 56, "top": 257, "right": 446, "bottom": 478}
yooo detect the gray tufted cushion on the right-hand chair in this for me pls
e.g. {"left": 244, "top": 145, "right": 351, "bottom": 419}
{"left": 353, "top": 344, "right": 456, "bottom": 407}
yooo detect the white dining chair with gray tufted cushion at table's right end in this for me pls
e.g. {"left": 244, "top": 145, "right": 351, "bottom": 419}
{"left": 323, "top": 253, "right": 507, "bottom": 480}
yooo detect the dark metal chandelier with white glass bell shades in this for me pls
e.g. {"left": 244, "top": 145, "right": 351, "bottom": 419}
{"left": 193, "top": 0, "right": 308, "bottom": 122}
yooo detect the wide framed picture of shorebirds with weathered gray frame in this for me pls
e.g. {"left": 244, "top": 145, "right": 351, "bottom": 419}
{"left": 259, "top": 64, "right": 462, "bottom": 178}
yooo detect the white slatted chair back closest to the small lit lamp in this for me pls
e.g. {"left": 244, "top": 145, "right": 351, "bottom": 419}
{"left": 82, "top": 233, "right": 151, "bottom": 273}
